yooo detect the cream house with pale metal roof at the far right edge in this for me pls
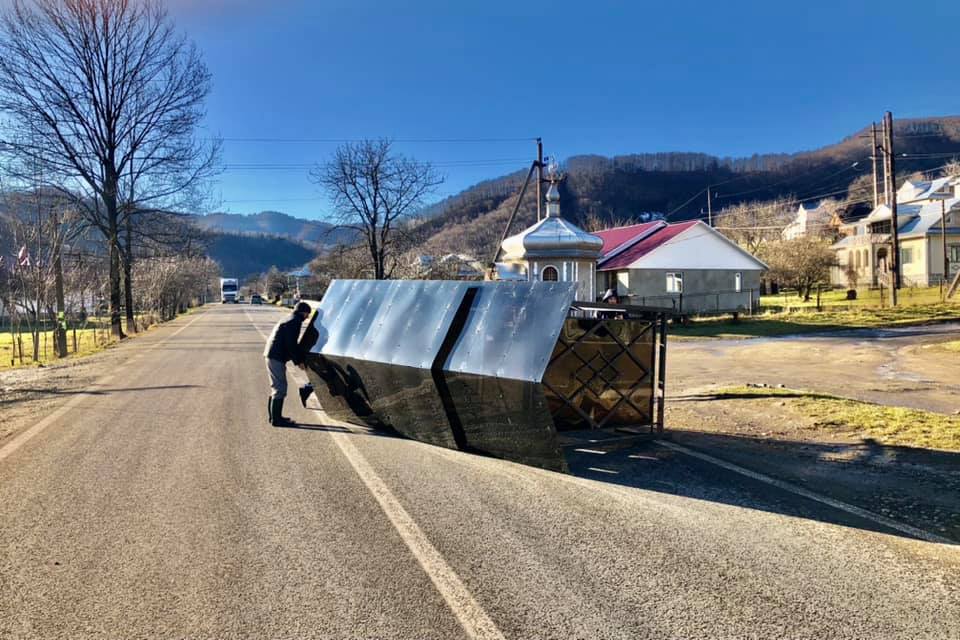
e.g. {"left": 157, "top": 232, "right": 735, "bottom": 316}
{"left": 830, "top": 178, "right": 960, "bottom": 289}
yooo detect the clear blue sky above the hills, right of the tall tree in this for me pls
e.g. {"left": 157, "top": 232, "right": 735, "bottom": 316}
{"left": 169, "top": 0, "right": 960, "bottom": 218}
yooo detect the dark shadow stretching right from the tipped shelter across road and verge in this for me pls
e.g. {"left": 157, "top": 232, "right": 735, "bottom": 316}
{"left": 567, "top": 431, "right": 960, "bottom": 544}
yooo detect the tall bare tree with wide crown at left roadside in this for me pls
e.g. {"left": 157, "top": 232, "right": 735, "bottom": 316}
{"left": 0, "top": 0, "right": 219, "bottom": 337}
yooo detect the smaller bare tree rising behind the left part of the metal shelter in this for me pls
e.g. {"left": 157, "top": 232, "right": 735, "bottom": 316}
{"left": 310, "top": 139, "right": 443, "bottom": 280}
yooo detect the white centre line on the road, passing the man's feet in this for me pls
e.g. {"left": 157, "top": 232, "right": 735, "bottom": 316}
{"left": 244, "top": 310, "right": 505, "bottom": 640}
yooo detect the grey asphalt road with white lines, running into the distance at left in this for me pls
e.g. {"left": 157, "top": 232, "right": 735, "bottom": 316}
{"left": 0, "top": 306, "right": 960, "bottom": 639}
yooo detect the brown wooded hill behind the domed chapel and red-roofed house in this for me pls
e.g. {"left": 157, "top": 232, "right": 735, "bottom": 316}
{"left": 419, "top": 116, "right": 960, "bottom": 258}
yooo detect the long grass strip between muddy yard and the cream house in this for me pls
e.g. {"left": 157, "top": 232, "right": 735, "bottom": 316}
{"left": 668, "top": 300, "right": 960, "bottom": 338}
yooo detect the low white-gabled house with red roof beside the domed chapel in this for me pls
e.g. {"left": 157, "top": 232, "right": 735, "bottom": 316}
{"left": 594, "top": 220, "right": 767, "bottom": 314}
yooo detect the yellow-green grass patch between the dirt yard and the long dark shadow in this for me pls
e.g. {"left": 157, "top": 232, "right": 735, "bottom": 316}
{"left": 711, "top": 386, "right": 960, "bottom": 451}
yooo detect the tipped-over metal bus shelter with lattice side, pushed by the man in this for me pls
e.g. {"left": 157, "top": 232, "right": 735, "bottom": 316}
{"left": 307, "top": 280, "right": 666, "bottom": 470}
